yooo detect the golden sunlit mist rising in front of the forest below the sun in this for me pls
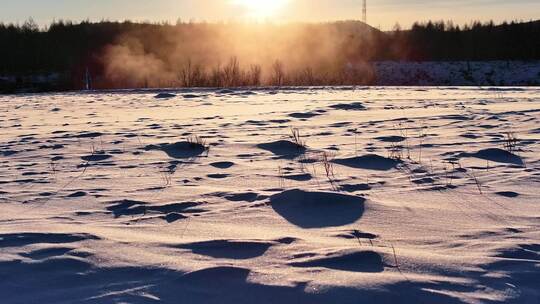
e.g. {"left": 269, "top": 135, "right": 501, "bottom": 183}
{"left": 101, "top": 22, "right": 380, "bottom": 87}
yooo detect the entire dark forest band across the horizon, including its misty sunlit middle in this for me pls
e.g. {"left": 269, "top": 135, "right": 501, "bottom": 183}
{"left": 0, "top": 20, "right": 540, "bottom": 92}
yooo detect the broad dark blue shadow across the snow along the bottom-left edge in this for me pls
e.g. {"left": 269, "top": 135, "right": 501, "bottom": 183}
{"left": 0, "top": 257, "right": 461, "bottom": 304}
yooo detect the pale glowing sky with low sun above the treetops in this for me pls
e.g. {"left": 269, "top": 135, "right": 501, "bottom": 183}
{"left": 0, "top": 0, "right": 540, "bottom": 30}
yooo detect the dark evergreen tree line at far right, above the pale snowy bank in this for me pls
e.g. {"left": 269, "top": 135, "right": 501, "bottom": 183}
{"left": 393, "top": 21, "right": 540, "bottom": 61}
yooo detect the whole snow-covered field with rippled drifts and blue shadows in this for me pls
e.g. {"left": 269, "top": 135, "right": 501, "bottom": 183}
{"left": 0, "top": 87, "right": 540, "bottom": 304}
